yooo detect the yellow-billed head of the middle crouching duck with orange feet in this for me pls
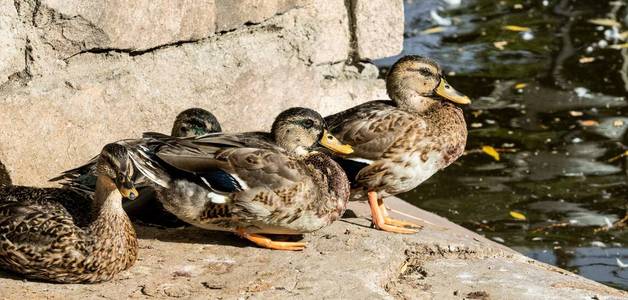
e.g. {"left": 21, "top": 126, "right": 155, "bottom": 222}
{"left": 271, "top": 107, "right": 353, "bottom": 157}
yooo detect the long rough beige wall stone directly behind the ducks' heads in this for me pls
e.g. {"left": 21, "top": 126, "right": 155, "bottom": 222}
{"left": 0, "top": 7, "right": 386, "bottom": 185}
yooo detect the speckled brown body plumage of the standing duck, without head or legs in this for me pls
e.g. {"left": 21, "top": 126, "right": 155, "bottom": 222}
{"left": 325, "top": 101, "right": 467, "bottom": 195}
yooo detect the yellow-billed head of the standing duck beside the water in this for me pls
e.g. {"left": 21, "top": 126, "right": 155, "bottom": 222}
{"left": 386, "top": 55, "right": 471, "bottom": 112}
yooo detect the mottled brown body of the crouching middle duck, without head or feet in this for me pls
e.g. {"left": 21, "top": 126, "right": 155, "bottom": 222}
{"left": 137, "top": 133, "right": 349, "bottom": 233}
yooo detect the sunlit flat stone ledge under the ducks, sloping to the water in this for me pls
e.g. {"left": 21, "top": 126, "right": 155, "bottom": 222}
{"left": 0, "top": 199, "right": 628, "bottom": 299}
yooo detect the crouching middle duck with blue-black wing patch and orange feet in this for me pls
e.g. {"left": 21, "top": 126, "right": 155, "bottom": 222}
{"left": 66, "top": 108, "right": 352, "bottom": 250}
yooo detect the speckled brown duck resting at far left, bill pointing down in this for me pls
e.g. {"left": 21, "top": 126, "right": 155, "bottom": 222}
{"left": 0, "top": 144, "right": 138, "bottom": 283}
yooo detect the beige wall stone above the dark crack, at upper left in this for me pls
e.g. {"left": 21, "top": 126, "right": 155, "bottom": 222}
{"left": 35, "top": 0, "right": 215, "bottom": 51}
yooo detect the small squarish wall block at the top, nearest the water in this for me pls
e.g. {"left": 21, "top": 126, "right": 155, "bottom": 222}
{"left": 351, "top": 0, "right": 404, "bottom": 60}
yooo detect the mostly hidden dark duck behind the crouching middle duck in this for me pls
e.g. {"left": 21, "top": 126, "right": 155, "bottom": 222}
{"left": 50, "top": 107, "right": 222, "bottom": 227}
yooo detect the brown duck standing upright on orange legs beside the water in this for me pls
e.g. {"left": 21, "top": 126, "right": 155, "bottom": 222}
{"left": 325, "top": 56, "right": 471, "bottom": 233}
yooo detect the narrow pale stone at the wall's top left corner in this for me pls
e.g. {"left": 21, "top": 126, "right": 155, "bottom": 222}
{"left": 0, "top": 0, "right": 26, "bottom": 85}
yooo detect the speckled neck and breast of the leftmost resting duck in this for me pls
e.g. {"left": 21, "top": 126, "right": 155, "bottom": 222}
{"left": 89, "top": 176, "right": 137, "bottom": 271}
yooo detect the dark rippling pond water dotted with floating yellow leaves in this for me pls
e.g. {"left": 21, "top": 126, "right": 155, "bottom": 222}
{"left": 376, "top": 0, "right": 628, "bottom": 290}
